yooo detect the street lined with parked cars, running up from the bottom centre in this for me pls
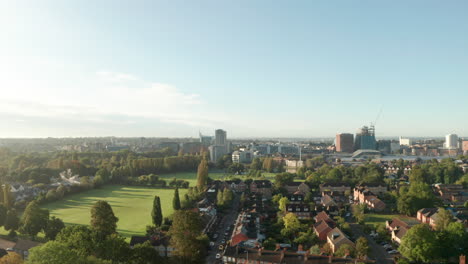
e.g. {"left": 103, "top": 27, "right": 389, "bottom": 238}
{"left": 206, "top": 194, "right": 240, "bottom": 264}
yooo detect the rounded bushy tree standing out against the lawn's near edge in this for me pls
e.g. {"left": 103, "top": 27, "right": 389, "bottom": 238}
{"left": 91, "top": 201, "right": 119, "bottom": 237}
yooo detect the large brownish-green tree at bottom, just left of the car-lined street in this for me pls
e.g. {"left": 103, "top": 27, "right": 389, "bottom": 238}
{"left": 169, "top": 210, "right": 207, "bottom": 263}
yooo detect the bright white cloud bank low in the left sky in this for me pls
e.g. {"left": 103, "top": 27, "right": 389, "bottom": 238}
{"left": 0, "top": 67, "right": 226, "bottom": 131}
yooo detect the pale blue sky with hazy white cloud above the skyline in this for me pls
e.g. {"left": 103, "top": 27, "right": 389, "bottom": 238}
{"left": 0, "top": 0, "right": 468, "bottom": 138}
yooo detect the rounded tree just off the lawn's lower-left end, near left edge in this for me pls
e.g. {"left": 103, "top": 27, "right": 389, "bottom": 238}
{"left": 20, "top": 201, "right": 49, "bottom": 238}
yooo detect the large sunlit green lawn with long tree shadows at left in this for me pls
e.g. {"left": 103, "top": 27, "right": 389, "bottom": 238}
{"left": 42, "top": 185, "right": 187, "bottom": 240}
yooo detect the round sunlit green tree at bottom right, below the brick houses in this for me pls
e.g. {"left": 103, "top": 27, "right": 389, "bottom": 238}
{"left": 398, "top": 224, "right": 437, "bottom": 262}
